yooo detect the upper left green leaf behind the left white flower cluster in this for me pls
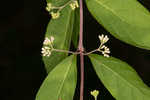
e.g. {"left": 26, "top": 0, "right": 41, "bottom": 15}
{"left": 43, "top": 3, "right": 74, "bottom": 73}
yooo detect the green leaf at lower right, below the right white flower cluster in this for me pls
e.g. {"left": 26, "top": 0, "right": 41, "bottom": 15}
{"left": 89, "top": 54, "right": 150, "bottom": 100}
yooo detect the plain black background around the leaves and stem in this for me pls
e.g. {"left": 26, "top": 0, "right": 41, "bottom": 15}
{"left": 0, "top": 0, "right": 150, "bottom": 100}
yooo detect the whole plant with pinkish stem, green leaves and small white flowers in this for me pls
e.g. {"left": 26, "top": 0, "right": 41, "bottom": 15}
{"left": 36, "top": 0, "right": 150, "bottom": 100}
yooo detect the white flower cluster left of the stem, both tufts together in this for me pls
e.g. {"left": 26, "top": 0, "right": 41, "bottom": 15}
{"left": 41, "top": 36, "right": 54, "bottom": 57}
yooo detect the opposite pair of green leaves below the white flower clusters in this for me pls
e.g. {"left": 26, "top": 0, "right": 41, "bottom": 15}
{"left": 36, "top": 54, "right": 150, "bottom": 100}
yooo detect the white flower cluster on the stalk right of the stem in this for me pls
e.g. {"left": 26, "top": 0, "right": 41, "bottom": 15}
{"left": 98, "top": 34, "right": 110, "bottom": 57}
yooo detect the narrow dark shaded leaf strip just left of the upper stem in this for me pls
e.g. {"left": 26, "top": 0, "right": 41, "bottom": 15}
{"left": 72, "top": 9, "right": 80, "bottom": 48}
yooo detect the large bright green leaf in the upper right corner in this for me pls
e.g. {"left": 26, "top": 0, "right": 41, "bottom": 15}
{"left": 86, "top": 0, "right": 150, "bottom": 50}
